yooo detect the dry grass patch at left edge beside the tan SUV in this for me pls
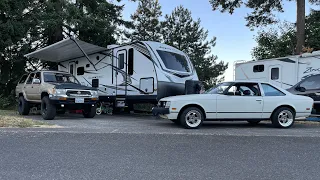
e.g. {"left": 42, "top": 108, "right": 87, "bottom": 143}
{"left": 0, "top": 110, "right": 50, "bottom": 128}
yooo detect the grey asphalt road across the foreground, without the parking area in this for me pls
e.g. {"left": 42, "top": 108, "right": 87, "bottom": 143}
{"left": 0, "top": 130, "right": 320, "bottom": 180}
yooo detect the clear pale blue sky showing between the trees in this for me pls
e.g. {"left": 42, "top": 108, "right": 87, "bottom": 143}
{"left": 121, "top": 0, "right": 318, "bottom": 80}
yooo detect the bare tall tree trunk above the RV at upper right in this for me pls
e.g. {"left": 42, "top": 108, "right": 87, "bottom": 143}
{"left": 296, "top": 0, "right": 306, "bottom": 54}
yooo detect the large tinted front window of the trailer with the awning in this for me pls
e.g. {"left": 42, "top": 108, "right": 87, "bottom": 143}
{"left": 157, "top": 50, "right": 190, "bottom": 72}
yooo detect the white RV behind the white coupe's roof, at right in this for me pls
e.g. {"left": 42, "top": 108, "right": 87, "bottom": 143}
{"left": 234, "top": 51, "right": 320, "bottom": 89}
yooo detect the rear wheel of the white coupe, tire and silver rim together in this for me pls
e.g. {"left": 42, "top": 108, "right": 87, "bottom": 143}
{"left": 271, "top": 107, "right": 295, "bottom": 128}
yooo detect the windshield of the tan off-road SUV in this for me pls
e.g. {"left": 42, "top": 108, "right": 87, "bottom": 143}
{"left": 43, "top": 72, "right": 80, "bottom": 84}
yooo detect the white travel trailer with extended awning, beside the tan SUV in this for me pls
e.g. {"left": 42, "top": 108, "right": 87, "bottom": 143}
{"left": 25, "top": 37, "right": 198, "bottom": 107}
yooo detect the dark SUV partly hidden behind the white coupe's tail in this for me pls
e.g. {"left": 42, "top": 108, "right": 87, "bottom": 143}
{"left": 287, "top": 74, "right": 320, "bottom": 114}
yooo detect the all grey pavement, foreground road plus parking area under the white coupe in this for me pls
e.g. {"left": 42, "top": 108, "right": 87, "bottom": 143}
{"left": 0, "top": 115, "right": 320, "bottom": 180}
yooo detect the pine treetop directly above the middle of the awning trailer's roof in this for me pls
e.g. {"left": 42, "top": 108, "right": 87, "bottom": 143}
{"left": 126, "top": 0, "right": 162, "bottom": 41}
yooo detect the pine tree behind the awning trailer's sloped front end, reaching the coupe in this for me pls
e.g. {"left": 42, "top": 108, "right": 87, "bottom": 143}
{"left": 161, "top": 6, "right": 228, "bottom": 87}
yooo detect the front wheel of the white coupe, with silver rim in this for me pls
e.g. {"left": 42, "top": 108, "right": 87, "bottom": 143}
{"left": 179, "top": 107, "right": 204, "bottom": 129}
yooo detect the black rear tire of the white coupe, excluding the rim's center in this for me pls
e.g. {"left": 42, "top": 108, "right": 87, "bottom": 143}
{"left": 271, "top": 107, "right": 295, "bottom": 128}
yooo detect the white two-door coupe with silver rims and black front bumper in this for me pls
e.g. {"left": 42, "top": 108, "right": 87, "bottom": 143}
{"left": 152, "top": 81, "right": 313, "bottom": 128}
